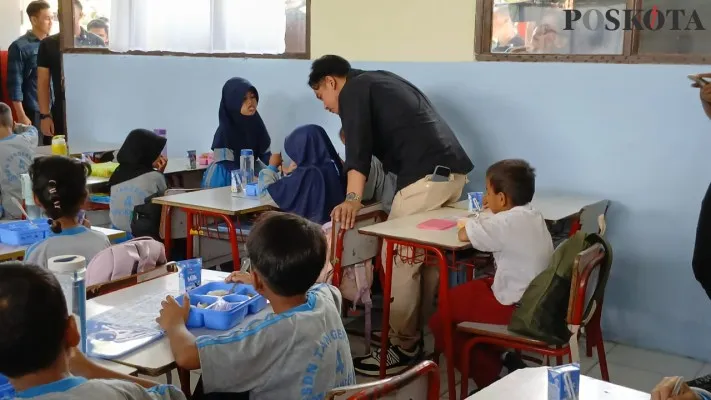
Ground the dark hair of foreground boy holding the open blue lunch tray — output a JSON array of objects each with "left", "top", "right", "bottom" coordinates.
[{"left": 247, "top": 212, "right": 326, "bottom": 297}]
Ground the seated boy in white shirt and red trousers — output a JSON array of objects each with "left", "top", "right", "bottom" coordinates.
[{"left": 429, "top": 160, "right": 553, "bottom": 389}]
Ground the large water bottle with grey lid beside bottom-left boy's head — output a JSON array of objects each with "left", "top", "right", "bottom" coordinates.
[{"left": 47, "top": 256, "right": 86, "bottom": 353}]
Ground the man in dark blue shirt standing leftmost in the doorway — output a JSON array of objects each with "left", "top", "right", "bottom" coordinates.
[{"left": 7, "top": 0, "right": 53, "bottom": 129}]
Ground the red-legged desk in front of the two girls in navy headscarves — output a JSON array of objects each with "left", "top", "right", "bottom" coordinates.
[{"left": 153, "top": 187, "right": 274, "bottom": 271}]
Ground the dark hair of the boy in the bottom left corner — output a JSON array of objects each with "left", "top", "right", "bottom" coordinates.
[{"left": 0, "top": 262, "right": 69, "bottom": 378}]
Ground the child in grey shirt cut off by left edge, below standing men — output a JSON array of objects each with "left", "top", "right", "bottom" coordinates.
[{"left": 0, "top": 103, "right": 37, "bottom": 219}]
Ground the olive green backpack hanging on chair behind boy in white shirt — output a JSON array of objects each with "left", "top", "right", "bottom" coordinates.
[{"left": 508, "top": 231, "right": 612, "bottom": 345}]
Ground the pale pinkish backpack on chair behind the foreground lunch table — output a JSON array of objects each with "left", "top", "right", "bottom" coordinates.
[{"left": 85, "top": 237, "right": 168, "bottom": 286}]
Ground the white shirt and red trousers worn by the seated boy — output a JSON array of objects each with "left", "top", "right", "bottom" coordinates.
[{"left": 429, "top": 205, "right": 553, "bottom": 389}]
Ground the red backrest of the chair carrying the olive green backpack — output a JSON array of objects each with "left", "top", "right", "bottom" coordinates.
[{"left": 566, "top": 243, "right": 610, "bottom": 326}]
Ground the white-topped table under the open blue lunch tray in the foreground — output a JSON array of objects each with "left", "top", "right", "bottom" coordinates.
[{"left": 86, "top": 269, "right": 271, "bottom": 393}]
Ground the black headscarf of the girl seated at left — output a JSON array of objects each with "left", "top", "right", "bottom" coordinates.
[{"left": 109, "top": 129, "right": 166, "bottom": 186}]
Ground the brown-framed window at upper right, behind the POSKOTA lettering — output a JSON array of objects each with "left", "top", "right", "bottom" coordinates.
[{"left": 475, "top": 0, "right": 711, "bottom": 63}]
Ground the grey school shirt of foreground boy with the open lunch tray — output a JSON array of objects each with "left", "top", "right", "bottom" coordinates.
[{"left": 197, "top": 284, "right": 356, "bottom": 400}]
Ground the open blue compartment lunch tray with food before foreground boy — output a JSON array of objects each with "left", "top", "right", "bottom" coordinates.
[{"left": 176, "top": 282, "right": 267, "bottom": 331}]
